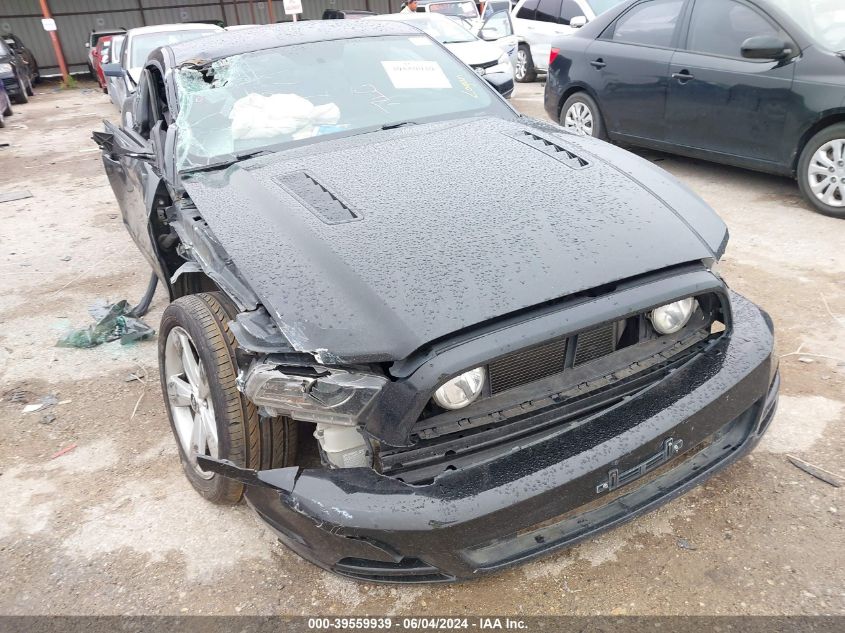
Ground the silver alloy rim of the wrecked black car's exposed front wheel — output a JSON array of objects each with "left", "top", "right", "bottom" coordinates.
[{"left": 164, "top": 326, "right": 220, "bottom": 479}]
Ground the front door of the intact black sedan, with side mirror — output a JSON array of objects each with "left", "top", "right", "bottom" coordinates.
[{"left": 667, "top": 0, "right": 800, "bottom": 163}]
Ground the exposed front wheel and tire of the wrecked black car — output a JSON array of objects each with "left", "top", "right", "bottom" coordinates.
[{"left": 158, "top": 292, "right": 296, "bottom": 504}]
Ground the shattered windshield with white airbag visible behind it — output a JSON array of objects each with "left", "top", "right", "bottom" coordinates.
[{"left": 176, "top": 35, "right": 511, "bottom": 171}]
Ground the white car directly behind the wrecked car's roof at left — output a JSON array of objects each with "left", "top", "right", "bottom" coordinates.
[{"left": 103, "top": 24, "right": 223, "bottom": 109}]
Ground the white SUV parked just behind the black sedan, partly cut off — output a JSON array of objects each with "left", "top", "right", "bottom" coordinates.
[{"left": 511, "top": 0, "right": 622, "bottom": 82}]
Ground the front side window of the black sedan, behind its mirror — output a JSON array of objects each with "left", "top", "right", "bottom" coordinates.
[{"left": 687, "top": 0, "right": 785, "bottom": 57}]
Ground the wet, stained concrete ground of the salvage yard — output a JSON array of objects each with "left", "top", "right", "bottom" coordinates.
[{"left": 0, "top": 76, "right": 845, "bottom": 615}]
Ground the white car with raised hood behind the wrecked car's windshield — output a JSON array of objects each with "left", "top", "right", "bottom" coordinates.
[{"left": 364, "top": 13, "right": 516, "bottom": 99}]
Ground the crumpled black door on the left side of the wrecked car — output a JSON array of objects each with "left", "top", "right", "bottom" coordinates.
[{"left": 94, "top": 70, "right": 166, "bottom": 279}]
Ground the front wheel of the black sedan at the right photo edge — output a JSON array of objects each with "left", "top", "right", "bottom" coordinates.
[{"left": 798, "top": 123, "right": 845, "bottom": 219}]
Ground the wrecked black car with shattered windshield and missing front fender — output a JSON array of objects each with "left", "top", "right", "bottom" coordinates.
[{"left": 95, "top": 20, "right": 779, "bottom": 582}]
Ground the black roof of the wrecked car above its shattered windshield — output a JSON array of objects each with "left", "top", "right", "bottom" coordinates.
[{"left": 167, "top": 20, "right": 420, "bottom": 66}]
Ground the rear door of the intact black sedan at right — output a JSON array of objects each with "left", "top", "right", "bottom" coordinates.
[{"left": 586, "top": 0, "right": 687, "bottom": 141}]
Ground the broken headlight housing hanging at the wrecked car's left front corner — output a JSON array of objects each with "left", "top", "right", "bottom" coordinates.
[{"left": 243, "top": 364, "right": 387, "bottom": 426}]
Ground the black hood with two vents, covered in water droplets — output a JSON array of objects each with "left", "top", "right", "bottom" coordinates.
[{"left": 184, "top": 118, "right": 725, "bottom": 362}]
